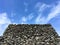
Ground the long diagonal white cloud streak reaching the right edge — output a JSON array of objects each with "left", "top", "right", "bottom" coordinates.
[{"left": 47, "top": 2, "right": 60, "bottom": 21}]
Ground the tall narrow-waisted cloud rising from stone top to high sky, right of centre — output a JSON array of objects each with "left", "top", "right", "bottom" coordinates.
[{"left": 35, "top": 2, "right": 50, "bottom": 24}]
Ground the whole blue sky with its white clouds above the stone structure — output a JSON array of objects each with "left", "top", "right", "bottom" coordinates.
[{"left": 0, "top": 0, "right": 60, "bottom": 35}]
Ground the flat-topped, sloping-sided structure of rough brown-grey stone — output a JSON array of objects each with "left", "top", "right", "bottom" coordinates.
[{"left": 0, "top": 24, "right": 60, "bottom": 45}]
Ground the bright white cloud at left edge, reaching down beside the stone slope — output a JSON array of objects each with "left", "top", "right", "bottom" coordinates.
[{"left": 0, "top": 13, "right": 11, "bottom": 35}]
